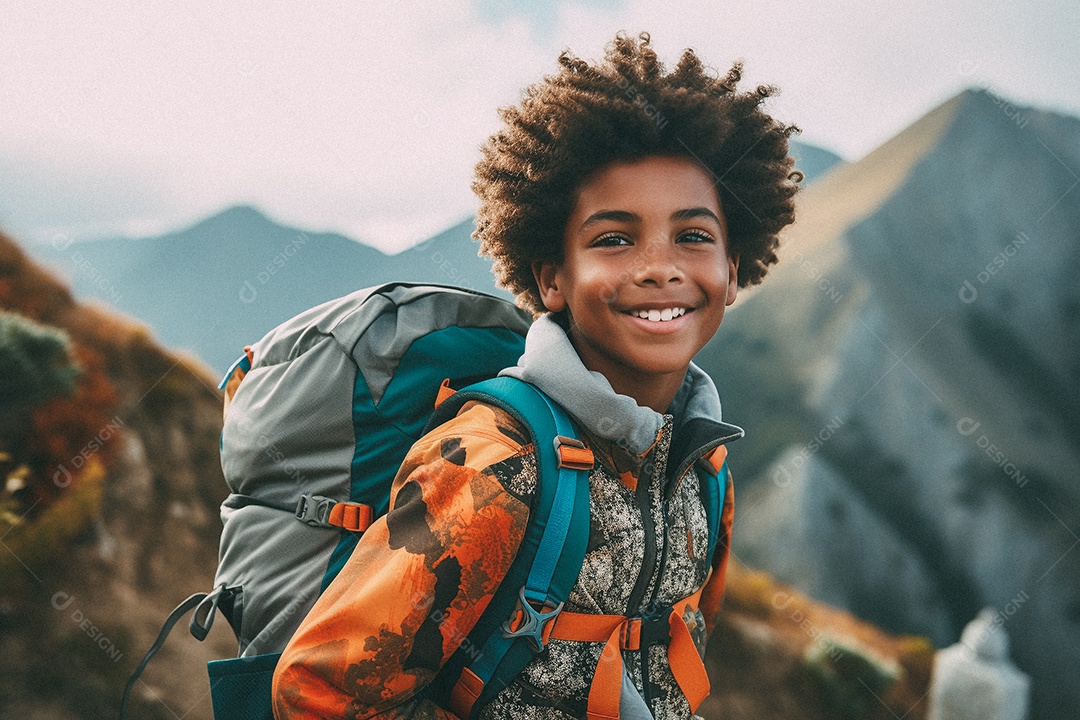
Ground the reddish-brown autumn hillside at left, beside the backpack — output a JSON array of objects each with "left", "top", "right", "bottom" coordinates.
[{"left": 0, "top": 235, "right": 234, "bottom": 720}]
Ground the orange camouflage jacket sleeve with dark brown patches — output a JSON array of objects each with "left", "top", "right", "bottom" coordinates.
[{"left": 273, "top": 403, "right": 535, "bottom": 720}]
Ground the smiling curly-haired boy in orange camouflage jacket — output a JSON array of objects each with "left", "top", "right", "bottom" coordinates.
[{"left": 274, "top": 35, "right": 798, "bottom": 720}]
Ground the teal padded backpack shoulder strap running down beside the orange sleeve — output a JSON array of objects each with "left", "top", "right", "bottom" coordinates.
[{"left": 429, "top": 377, "right": 593, "bottom": 720}]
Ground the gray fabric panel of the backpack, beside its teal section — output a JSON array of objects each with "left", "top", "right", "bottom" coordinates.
[{"left": 214, "top": 284, "right": 528, "bottom": 656}]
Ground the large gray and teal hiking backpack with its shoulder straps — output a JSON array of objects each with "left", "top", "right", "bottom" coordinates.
[{"left": 121, "top": 283, "right": 726, "bottom": 720}]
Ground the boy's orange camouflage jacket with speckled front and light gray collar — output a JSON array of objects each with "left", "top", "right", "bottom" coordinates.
[{"left": 274, "top": 315, "right": 742, "bottom": 720}]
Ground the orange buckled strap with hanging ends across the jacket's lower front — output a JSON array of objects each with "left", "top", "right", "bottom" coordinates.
[{"left": 551, "top": 590, "right": 708, "bottom": 720}]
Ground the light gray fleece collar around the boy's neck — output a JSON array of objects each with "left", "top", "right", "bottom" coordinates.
[{"left": 499, "top": 314, "right": 720, "bottom": 454}]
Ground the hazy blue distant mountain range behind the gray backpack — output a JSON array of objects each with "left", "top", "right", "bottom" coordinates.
[{"left": 21, "top": 144, "right": 841, "bottom": 372}]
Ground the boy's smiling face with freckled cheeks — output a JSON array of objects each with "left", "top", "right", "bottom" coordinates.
[{"left": 534, "top": 157, "right": 739, "bottom": 411}]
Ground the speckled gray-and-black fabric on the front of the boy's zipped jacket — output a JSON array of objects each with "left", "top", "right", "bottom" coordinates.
[{"left": 481, "top": 416, "right": 708, "bottom": 720}]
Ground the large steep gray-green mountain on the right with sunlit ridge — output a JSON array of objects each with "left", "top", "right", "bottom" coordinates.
[{"left": 699, "top": 91, "right": 1080, "bottom": 718}]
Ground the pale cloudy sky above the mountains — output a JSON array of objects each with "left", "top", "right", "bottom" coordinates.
[{"left": 0, "top": 0, "right": 1080, "bottom": 252}]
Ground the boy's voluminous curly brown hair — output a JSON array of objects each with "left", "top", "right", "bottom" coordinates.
[{"left": 472, "top": 32, "right": 802, "bottom": 312}]
